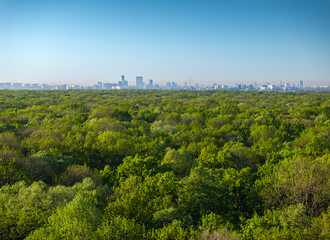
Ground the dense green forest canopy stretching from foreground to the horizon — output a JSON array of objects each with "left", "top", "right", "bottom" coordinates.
[{"left": 0, "top": 90, "right": 330, "bottom": 240}]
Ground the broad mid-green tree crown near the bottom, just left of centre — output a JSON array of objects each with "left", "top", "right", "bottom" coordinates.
[{"left": 106, "top": 172, "right": 177, "bottom": 223}]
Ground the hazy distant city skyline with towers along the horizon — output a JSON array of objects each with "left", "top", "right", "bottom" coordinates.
[{"left": 0, "top": 75, "right": 330, "bottom": 92}]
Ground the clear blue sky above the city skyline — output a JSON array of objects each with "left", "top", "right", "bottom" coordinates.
[{"left": 0, "top": 0, "right": 330, "bottom": 84}]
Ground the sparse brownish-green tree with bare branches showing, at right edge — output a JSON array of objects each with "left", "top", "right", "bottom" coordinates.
[{"left": 261, "top": 155, "right": 330, "bottom": 214}]
